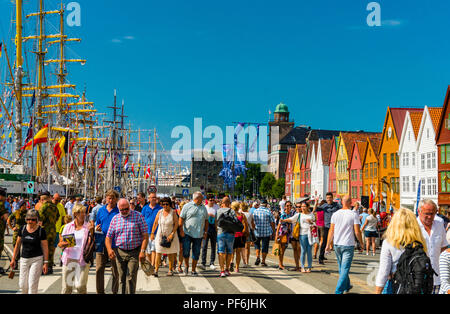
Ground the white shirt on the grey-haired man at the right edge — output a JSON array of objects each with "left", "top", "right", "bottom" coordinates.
[{"left": 417, "top": 216, "right": 448, "bottom": 286}]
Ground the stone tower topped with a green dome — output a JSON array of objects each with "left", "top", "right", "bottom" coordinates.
[{"left": 268, "top": 103, "right": 294, "bottom": 179}]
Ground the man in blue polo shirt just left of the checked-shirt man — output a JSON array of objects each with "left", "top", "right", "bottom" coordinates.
[{"left": 95, "top": 190, "right": 119, "bottom": 294}]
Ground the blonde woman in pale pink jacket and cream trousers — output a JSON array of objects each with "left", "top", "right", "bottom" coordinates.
[{"left": 58, "top": 204, "right": 94, "bottom": 294}]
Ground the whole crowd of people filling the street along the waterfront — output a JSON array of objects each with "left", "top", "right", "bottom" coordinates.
[{"left": 0, "top": 190, "right": 450, "bottom": 294}]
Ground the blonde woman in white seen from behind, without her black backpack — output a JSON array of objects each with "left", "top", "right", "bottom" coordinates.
[{"left": 375, "top": 208, "right": 427, "bottom": 294}]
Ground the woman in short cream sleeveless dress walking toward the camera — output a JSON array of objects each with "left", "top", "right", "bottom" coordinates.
[{"left": 151, "top": 197, "right": 180, "bottom": 277}]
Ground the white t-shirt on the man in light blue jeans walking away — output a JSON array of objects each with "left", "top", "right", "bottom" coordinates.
[{"left": 331, "top": 209, "right": 360, "bottom": 246}]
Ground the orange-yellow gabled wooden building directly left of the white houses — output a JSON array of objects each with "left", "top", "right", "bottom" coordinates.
[{"left": 378, "top": 107, "right": 423, "bottom": 209}]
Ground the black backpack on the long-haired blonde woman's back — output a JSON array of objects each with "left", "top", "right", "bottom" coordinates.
[{"left": 392, "top": 242, "right": 437, "bottom": 294}]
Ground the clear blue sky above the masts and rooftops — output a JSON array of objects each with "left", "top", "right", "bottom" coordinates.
[{"left": 0, "top": 0, "right": 450, "bottom": 156}]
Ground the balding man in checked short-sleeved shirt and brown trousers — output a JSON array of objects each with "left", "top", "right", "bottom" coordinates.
[{"left": 105, "top": 199, "right": 148, "bottom": 294}]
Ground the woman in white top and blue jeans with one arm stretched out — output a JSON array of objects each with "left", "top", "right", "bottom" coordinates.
[{"left": 281, "top": 202, "right": 316, "bottom": 273}]
